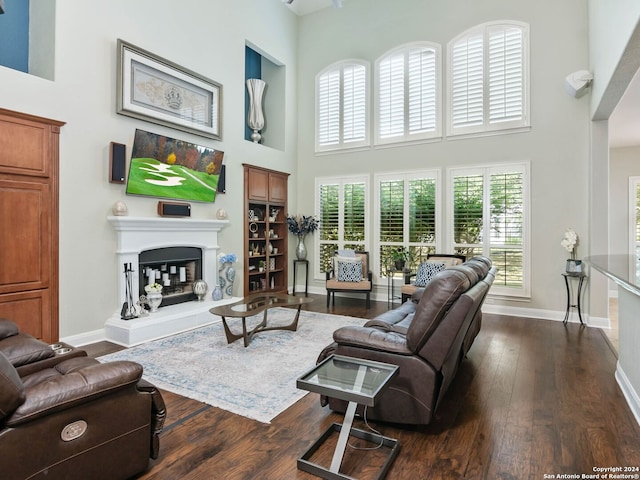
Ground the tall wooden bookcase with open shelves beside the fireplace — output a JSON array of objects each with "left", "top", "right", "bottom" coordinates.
[{"left": 244, "top": 164, "right": 289, "bottom": 296}]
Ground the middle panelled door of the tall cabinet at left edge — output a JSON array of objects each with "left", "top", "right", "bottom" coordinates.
[{"left": 0, "top": 179, "right": 51, "bottom": 294}]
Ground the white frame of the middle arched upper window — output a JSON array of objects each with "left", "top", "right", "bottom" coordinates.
[{"left": 373, "top": 41, "right": 443, "bottom": 147}]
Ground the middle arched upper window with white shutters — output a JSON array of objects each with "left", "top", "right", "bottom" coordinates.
[{"left": 375, "top": 42, "right": 441, "bottom": 144}]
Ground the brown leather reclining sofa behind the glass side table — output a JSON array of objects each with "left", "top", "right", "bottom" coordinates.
[{"left": 318, "top": 257, "right": 497, "bottom": 425}]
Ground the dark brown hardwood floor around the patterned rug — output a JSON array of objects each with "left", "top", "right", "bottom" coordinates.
[{"left": 85, "top": 295, "right": 640, "bottom": 480}]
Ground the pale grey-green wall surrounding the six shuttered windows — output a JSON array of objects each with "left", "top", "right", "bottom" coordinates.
[{"left": 297, "top": 0, "right": 589, "bottom": 311}]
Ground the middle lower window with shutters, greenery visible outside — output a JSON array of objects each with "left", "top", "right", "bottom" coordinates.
[{"left": 374, "top": 171, "right": 440, "bottom": 275}]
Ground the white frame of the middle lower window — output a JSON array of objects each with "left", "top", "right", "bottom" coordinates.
[{"left": 371, "top": 168, "right": 443, "bottom": 278}]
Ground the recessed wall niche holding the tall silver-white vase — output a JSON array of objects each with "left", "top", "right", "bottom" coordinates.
[{"left": 243, "top": 42, "right": 286, "bottom": 150}]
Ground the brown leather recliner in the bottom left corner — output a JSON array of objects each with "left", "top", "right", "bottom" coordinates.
[{"left": 0, "top": 319, "right": 166, "bottom": 480}]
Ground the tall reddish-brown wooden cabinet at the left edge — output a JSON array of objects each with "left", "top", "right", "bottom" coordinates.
[{"left": 0, "top": 109, "right": 64, "bottom": 342}]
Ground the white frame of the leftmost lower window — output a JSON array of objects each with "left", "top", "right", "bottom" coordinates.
[{"left": 313, "top": 174, "right": 371, "bottom": 280}]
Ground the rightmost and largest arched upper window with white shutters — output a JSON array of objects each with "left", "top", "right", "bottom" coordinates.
[{"left": 447, "top": 22, "right": 530, "bottom": 135}]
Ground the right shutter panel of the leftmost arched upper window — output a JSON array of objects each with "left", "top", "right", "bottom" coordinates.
[{"left": 342, "top": 65, "right": 367, "bottom": 143}]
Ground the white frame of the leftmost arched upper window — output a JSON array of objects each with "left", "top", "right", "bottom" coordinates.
[{"left": 315, "top": 59, "right": 371, "bottom": 153}]
